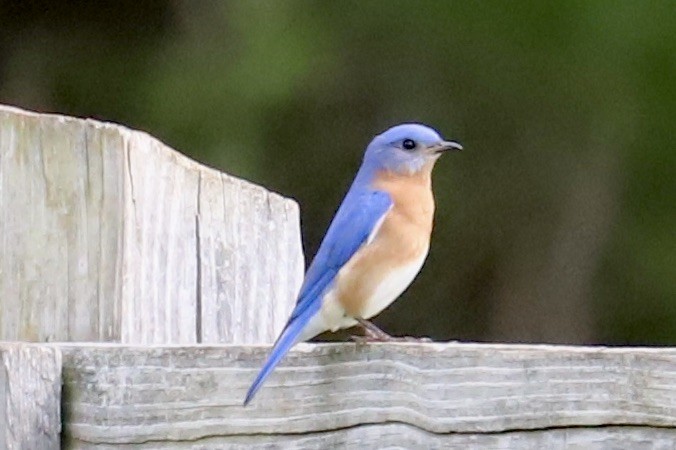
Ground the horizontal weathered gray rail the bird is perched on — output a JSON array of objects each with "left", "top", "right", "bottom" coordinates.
[{"left": 60, "top": 343, "right": 676, "bottom": 448}]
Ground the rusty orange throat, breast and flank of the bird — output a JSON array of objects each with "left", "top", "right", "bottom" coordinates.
[{"left": 336, "top": 163, "right": 434, "bottom": 318}]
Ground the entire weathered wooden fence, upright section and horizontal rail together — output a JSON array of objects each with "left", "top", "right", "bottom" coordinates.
[{"left": 0, "top": 107, "right": 676, "bottom": 450}]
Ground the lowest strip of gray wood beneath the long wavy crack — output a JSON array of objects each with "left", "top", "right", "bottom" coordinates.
[{"left": 58, "top": 423, "right": 676, "bottom": 450}]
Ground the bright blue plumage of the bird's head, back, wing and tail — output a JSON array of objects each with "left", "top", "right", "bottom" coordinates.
[{"left": 244, "top": 124, "right": 462, "bottom": 405}]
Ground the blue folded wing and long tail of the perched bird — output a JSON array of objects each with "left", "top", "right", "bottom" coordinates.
[{"left": 244, "top": 190, "right": 392, "bottom": 405}]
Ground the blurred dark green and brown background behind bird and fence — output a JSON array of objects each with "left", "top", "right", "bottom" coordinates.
[{"left": 0, "top": 0, "right": 676, "bottom": 344}]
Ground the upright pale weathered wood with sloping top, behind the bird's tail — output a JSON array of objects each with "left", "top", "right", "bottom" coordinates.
[{"left": 0, "top": 105, "right": 303, "bottom": 344}]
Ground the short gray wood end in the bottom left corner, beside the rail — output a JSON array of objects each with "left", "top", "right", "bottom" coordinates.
[{"left": 0, "top": 342, "right": 61, "bottom": 450}]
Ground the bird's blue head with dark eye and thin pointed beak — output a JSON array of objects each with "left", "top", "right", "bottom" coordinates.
[{"left": 364, "top": 123, "right": 462, "bottom": 175}]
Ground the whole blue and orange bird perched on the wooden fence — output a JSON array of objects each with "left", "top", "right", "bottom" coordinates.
[{"left": 244, "top": 123, "right": 463, "bottom": 406}]
